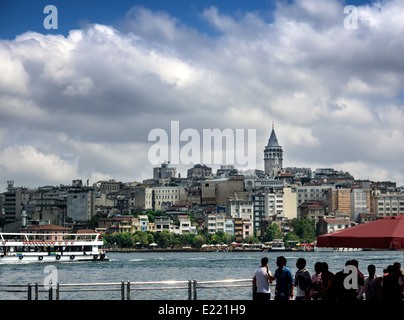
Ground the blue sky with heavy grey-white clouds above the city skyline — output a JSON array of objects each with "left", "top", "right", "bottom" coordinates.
[{"left": 0, "top": 0, "right": 404, "bottom": 190}]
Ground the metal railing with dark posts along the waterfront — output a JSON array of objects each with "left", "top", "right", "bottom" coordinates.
[{"left": 0, "top": 279, "right": 253, "bottom": 300}]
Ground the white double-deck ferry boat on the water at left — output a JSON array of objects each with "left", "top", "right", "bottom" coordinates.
[{"left": 0, "top": 233, "right": 108, "bottom": 263}]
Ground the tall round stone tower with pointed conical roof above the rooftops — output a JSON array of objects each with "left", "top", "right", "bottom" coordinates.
[{"left": 264, "top": 122, "right": 283, "bottom": 178}]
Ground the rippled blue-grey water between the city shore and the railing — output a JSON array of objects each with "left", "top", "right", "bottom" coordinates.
[{"left": 0, "top": 251, "right": 403, "bottom": 300}]
